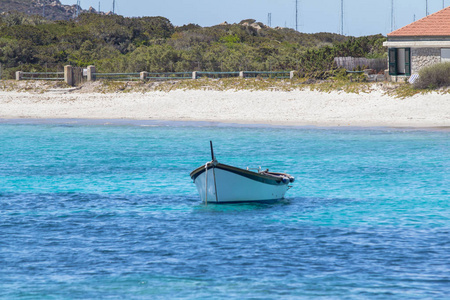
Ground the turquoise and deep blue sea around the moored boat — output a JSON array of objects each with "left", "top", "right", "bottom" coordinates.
[{"left": 0, "top": 120, "right": 450, "bottom": 299}]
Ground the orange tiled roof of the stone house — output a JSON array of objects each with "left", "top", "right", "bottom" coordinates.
[{"left": 388, "top": 6, "right": 450, "bottom": 37}]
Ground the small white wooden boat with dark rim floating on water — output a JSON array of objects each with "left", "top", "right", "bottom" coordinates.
[{"left": 190, "top": 142, "right": 294, "bottom": 203}]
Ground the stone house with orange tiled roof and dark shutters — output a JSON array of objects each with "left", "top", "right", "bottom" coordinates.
[{"left": 383, "top": 7, "right": 450, "bottom": 80}]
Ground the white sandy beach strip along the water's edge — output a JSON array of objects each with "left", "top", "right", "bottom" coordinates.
[{"left": 0, "top": 90, "right": 450, "bottom": 127}]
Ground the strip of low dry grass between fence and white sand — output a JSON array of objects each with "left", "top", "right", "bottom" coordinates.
[{"left": 0, "top": 78, "right": 450, "bottom": 99}]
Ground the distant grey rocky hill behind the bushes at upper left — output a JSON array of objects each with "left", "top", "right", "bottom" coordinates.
[{"left": 0, "top": 0, "right": 96, "bottom": 20}]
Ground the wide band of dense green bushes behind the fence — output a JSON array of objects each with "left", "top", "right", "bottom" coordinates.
[{"left": 0, "top": 13, "right": 386, "bottom": 79}]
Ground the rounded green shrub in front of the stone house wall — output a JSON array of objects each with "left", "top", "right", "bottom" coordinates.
[{"left": 414, "top": 62, "right": 450, "bottom": 89}]
